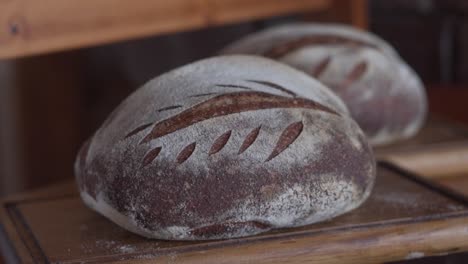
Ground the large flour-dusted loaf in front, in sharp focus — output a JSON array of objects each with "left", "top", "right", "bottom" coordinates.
[{"left": 75, "top": 56, "right": 375, "bottom": 240}]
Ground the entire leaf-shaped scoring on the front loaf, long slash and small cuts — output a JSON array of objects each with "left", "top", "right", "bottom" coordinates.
[{"left": 125, "top": 80, "right": 340, "bottom": 167}]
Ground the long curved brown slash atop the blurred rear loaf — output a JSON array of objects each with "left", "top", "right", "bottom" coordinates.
[{"left": 263, "top": 35, "right": 380, "bottom": 59}]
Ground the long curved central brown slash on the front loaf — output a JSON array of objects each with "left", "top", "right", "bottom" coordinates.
[{"left": 140, "top": 92, "right": 340, "bottom": 144}]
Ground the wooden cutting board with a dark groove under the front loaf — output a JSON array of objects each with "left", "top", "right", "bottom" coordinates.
[{"left": 0, "top": 163, "right": 468, "bottom": 263}]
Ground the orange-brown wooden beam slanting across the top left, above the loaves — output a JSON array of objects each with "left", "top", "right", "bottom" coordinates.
[{"left": 0, "top": 0, "right": 332, "bottom": 59}]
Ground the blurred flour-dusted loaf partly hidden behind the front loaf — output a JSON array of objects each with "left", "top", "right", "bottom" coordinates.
[{"left": 221, "top": 23, "right": 427, "bottom": 145}]
